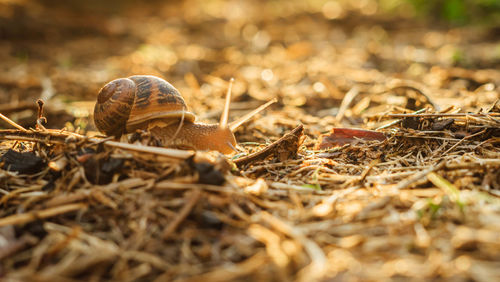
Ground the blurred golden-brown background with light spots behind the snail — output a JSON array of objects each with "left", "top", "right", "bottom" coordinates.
[{"left": 0, "top": 0, "right": 500, "bottom": 131}]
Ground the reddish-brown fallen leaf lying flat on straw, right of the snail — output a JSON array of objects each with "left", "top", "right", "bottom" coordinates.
[{"left": 315, "top": 128, "right": 387, "bottom": 150}]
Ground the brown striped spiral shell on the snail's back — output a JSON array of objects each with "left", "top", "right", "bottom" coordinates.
[{"left": 94, "top": 75, "right": 195, "bottom": 136}]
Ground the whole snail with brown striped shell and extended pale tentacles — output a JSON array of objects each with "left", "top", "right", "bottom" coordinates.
[{"left": 94, "top": 75, "right": 275, "bottom": 154}]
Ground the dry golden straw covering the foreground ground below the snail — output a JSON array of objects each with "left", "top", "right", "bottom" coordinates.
[{"left": 0, "top": 103, "right": 500, "bottom": 281}]
